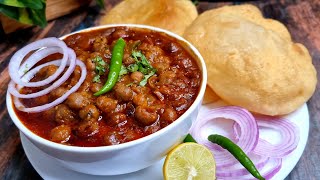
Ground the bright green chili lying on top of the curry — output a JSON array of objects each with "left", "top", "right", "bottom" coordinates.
[{"left": 94, "top": 38, "right": 126, "bottom": 96}]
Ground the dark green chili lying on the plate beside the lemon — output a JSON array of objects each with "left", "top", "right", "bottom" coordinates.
[{"left": 208, "top": 134, "right": 264, "bottom": 180}]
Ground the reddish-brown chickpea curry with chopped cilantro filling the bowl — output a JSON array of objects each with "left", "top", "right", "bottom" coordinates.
[{"left": 15, "top": 27, "right": 201, "bottom": 147}]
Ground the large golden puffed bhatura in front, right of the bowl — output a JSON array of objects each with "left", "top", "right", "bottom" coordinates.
[{"left": 184, "top": 5, "right": 317, "bottom": 115}]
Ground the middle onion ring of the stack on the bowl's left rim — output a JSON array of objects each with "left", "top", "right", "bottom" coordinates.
[{"left": 8, "top": 49, "right": 76, "bottom": 98}]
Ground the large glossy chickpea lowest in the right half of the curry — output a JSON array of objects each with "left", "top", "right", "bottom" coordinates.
[{"left": 134, "top": 106, "right": 159, "bottom": 126}]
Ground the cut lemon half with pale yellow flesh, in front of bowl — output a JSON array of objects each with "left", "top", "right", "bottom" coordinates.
[{"left": 163, "top": 143, "right": 216, "bottom": 180}]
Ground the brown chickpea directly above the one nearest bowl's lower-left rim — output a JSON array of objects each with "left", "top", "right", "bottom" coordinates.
[{"left": 55, "top": 104, "right": 77, "bottom": 124}]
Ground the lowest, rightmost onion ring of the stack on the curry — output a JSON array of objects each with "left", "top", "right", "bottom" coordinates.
[{"left": 13, "top": 60, "right": 87, "bottom": 112}]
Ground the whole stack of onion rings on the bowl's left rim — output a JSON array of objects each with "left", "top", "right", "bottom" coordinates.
[{"left": 8, "top": 37, "right": 87, "bottom": 112}]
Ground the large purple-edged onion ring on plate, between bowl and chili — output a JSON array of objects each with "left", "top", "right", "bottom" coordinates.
[{"left": 190, "top": 106, "right": 259, "bottom": 167}]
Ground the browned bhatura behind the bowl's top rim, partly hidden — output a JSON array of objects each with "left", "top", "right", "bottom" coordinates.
[{"left": 100, "top": 0, "right": 198, "bottom": 35}]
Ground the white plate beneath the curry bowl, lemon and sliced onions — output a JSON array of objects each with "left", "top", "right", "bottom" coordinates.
[{"left": 20, "top": 104, "right": 309, "bottom": 180}]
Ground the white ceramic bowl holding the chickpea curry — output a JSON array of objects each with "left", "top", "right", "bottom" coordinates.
[{"left": 6, "top": 24, "right": 207, "bottom": 175}]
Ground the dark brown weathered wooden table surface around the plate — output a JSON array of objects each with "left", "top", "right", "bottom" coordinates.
[{"left": 0, "top": 0, "right": 320, "bottom": 180}]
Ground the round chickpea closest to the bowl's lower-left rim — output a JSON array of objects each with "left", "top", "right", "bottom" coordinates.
[{"left": 50, "top": 125, "right": 71, "bottom": 143}]
